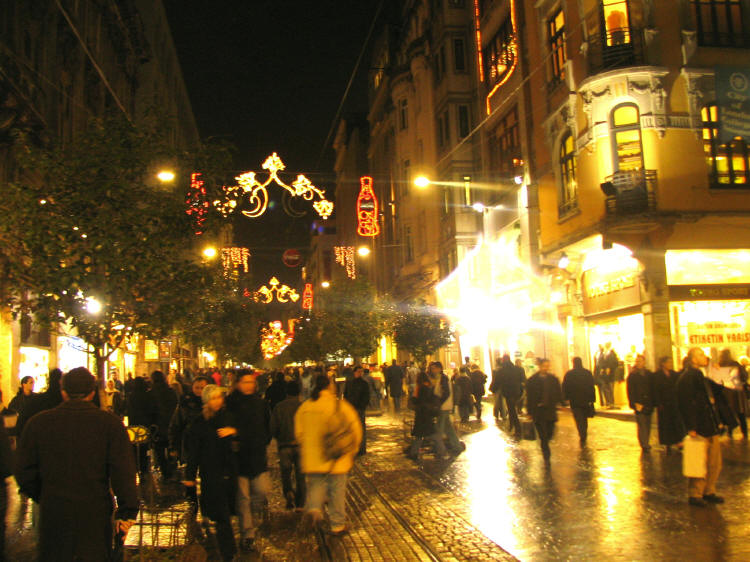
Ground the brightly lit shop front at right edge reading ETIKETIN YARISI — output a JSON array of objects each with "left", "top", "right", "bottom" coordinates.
[{"left": 665, "top": 249, "right": 750, "bottom": 365}]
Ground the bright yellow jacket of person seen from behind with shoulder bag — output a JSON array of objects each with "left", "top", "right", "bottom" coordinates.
[{"left": 294, "top": 389, "right": 362, "bottom": 474}]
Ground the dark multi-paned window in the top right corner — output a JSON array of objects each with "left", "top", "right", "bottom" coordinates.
[{"left": 692, "top": 0, "right": 750, "bottom": 47}]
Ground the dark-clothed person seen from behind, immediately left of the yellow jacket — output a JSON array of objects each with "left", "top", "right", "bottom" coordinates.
[{"left": 271, "top": 380, "right": 306, "bottom": 509}]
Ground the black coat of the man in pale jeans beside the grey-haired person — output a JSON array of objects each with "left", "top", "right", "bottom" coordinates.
[{"left": 226, "top": 390, "right": 271, "bottom": 478}]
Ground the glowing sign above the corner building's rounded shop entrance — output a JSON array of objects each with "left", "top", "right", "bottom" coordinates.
[{"left": 583, "top": 269, "right": 641, "bottom": 315}]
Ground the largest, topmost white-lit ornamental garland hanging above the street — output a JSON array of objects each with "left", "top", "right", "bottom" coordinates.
[{"left": 214, "top": 152, "right": 333, "bottom": 220}]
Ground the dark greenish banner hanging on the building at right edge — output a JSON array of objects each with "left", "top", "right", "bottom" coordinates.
[{"left": 716, "top": 66, "right": 750, "bottom": 143}]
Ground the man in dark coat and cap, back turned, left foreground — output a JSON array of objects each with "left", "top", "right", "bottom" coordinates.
[{"left": 15, "top": 367, "right": 138, "bottom": 562}]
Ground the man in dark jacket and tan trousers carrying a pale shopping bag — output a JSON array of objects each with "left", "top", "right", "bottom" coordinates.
[{"left": 677, "top": 347, "right": 737, "bottom": 507}]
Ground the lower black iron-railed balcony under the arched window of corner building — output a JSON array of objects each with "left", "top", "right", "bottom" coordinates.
[{"left": 601, "top": 170, "right": 656, "bottom": 215}]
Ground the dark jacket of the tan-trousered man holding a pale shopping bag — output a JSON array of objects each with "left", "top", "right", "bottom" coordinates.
[{"left": 677, "top": 367, "right": 737, "bottom": 437}]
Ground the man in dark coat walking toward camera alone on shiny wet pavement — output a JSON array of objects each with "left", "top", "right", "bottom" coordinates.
[{"left": 526, "top": 359, "right": 562, "bottom": 465}]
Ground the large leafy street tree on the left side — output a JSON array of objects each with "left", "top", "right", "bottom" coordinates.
[{"left": 0, "top": 112, "right": 228, "bottom": 377}]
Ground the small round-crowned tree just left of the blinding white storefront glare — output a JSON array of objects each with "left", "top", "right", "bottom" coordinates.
[{"left": 392, "top": 301, "right": 453, "bottom": 364}]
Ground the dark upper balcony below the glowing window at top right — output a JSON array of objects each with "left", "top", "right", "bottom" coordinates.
[{"left": 588, "top": 28, "right": 647, "bottom": 75}]
